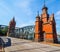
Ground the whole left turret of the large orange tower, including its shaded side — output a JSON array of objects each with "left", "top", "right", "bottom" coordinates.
[{"left": 34, "top": 12, "right": 43, "bottom": 41}]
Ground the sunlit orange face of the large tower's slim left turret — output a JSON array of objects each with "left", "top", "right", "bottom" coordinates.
[{"left": 35, "top": 12, "right": 40, "bottom": 41}]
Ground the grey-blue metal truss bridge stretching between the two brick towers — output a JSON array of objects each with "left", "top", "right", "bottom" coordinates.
[{"left": 0, "top": 25, "right": 60, "bottom": 41}]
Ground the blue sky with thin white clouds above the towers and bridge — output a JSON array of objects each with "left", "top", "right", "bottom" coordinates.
[{"left": 0, "top": 0, "right": 60, "bottom": 34}]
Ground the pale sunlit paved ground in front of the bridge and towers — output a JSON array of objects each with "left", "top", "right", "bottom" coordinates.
[{"left": 5, "top": 38, "right": 60, "bottom": 52}]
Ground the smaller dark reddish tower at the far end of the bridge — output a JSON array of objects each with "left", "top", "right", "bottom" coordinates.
[{"left": 8, "top": 17, "right": 16, "bottom": 36}]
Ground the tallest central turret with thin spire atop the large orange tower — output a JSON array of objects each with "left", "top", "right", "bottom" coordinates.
[{"left": 41, "top": 0, "right": 49, "bottom": 23}]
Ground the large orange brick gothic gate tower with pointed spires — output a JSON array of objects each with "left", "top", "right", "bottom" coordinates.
[{"left": 35, "top": 2, "right": 58, "bottom": 43}]
